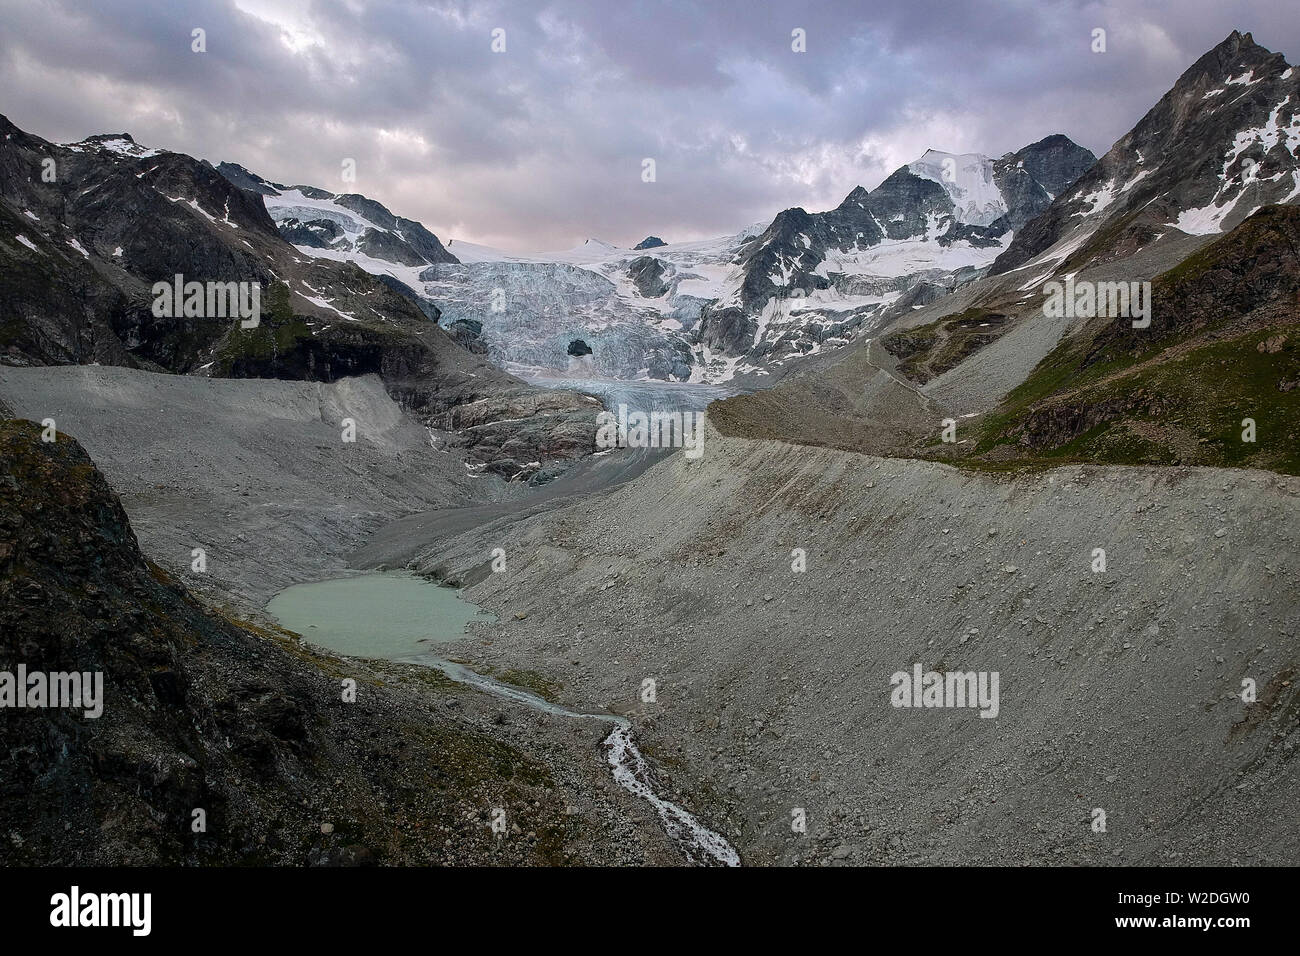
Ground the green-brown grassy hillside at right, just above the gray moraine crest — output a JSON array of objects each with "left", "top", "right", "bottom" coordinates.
[{"left": 963, "top": 206, "right": 1300, "bottom": 475}]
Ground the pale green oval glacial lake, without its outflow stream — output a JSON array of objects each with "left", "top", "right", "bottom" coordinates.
[{"left": 267, "top": 571, "right": 495, "bottom": 661}]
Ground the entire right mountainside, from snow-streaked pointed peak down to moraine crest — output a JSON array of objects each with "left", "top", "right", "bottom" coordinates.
[{"left": 710, "top": 33, "right": 1300, "bottom": 471}]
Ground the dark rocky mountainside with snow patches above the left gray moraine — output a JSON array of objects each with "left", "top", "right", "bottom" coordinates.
[{"left": 0, "top": 117, "right": 594, "bottom": 477}]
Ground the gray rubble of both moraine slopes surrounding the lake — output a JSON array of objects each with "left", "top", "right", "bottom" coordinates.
[{"left": 0, "top": 368, "right": 1300, "bottom": 865}]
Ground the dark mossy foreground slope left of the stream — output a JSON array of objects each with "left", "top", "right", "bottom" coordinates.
[{"left": 0, "top": 420, "right": 673, "bottom": 865}]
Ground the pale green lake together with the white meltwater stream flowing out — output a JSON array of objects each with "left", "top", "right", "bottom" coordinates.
[{"left": 267, "top": 571, "right": 740, "bottom": 866}]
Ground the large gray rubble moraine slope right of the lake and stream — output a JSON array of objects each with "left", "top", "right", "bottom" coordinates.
[{"left": 405, "top": 434, "right": 1300, "bottom": 865}]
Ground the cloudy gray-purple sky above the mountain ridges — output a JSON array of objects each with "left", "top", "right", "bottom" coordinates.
[{"left": 0, "top": 0, "right": 1300, "bottom": 251}]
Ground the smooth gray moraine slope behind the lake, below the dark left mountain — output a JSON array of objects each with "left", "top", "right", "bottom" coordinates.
[{"left": 0, "top": 365, "right": 486, "bottom": 607}]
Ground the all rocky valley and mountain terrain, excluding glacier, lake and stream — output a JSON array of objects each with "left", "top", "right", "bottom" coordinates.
[{"left": 0, "top": 33, "right": 1300, "bottom": 865}]
